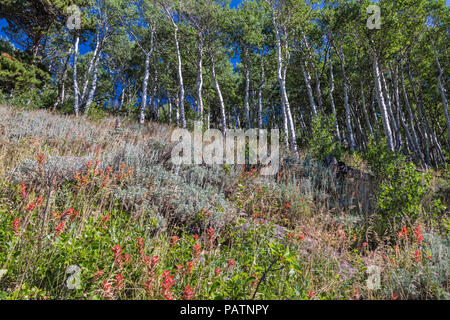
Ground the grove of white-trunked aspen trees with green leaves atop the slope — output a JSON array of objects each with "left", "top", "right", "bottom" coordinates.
[{"left": 0, "top": 0, "right": 450, "bottom": 167}]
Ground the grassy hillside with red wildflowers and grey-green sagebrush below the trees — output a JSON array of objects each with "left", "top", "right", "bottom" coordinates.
[{"left": 0, "top": 107, "right": 450, "bottom": 299}]
